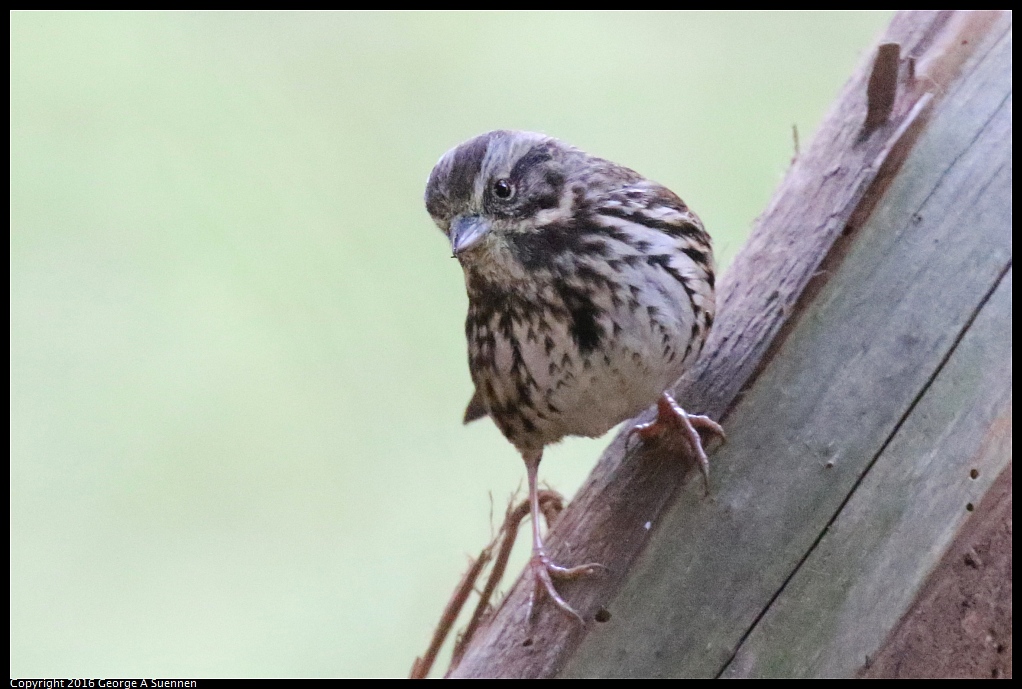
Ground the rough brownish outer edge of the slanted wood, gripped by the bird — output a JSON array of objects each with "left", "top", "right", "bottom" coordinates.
[{"left": 451, "top": 11, "right": 1000, "bottom": 677}]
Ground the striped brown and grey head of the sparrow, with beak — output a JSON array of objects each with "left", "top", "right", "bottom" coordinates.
[{"left": 425, "top": 130, "right": 596, "bottom": 268}]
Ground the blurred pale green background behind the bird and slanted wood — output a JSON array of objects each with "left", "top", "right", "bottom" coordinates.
[{"left": 10, "top": 12, "right": 889, "bottom": 677}]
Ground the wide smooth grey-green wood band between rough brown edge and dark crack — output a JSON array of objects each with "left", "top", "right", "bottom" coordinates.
[{"left": 564, "top": 16, "right": 1012, "bottom": 677}]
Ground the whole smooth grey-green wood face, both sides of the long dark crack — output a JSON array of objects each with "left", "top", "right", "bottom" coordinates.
[{"left": 562, "top": 18, "right": 1012, "bottom": 677}]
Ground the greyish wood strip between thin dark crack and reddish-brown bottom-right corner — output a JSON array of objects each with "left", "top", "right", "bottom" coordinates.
[{"left": 725, "top": 271, "right": 1012, "bottom": 677}]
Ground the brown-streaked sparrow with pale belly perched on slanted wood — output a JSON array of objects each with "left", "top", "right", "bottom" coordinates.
[{"left": 425, "top": 131, "right": 723, "bottom": 616}]
